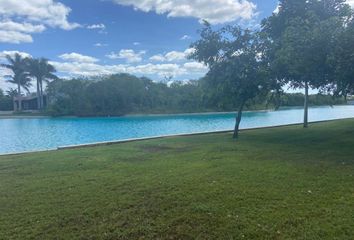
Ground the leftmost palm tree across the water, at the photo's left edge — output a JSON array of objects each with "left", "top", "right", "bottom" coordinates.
[{"left": 1, "top": 53, "right": 31, "bottom": 111}]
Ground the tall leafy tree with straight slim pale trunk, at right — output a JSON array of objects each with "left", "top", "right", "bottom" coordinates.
[{"left": 262, "top": 0, "right": 348, "bottom": 127}]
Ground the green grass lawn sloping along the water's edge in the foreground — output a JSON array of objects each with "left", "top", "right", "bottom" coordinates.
[{"left": 0, "top": 120, "right": 354, "bottom": 240}]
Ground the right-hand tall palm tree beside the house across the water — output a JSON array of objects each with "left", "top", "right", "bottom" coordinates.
[{"left": 28, "top": 58, "right": 58, "bottom": 109}]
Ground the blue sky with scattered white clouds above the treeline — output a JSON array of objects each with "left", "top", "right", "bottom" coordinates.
[{"left": 0, "top": 0, "right": 277, "bottom": 87}]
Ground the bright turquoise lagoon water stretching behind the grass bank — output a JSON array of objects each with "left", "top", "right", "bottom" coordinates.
[{"left": 0, "top": 106, "right": 354, "bottom": 154}]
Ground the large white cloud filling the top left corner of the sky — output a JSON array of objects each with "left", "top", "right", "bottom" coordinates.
[{"left": 0, "top": 0, "right": 80, "bottom": 43}]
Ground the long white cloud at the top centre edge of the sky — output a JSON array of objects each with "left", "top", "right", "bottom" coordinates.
[{"left": 113, "top": 0, "right": 256, "bottom": 24}]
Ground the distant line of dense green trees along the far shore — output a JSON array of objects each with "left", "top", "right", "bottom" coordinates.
[{"left": 24, "top": 74, "right": 345, "bottom": 116}]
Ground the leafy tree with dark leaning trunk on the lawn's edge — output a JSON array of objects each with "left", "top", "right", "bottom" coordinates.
[{"left": 190, "top": 22, "right": 268, "bottom": 138}]
